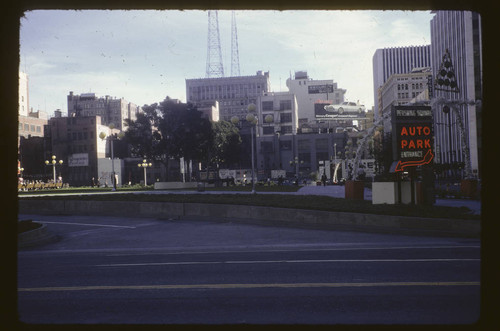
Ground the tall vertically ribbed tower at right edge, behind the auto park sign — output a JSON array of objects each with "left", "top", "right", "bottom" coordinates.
[{"left": 431, "top": 11, "right": 482, "bottom": 174}]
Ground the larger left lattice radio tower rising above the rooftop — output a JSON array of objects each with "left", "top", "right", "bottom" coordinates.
[{"left": 206, "top": 10, "right": 224, "bottom": 78}]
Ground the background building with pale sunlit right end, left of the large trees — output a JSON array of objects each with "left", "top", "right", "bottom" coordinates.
[{"left": 68, "top": 91, "right": 142, "bottom": 131}]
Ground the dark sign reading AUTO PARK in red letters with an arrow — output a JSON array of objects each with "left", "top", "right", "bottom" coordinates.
[{"left": 391, "top": 106, "right": 434, "bottom": 172}]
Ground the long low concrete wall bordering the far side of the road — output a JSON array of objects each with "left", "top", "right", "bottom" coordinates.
[{"left": 19, "top": 200, "right": 481, "bottom": 238}]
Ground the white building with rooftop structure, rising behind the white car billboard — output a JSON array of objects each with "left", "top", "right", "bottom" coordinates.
[{"left": 286, "top": 71, "right": 346, "bottom": 123}]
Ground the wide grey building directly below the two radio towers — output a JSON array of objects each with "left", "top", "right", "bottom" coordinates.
[{"left": 186, "top": 71, "right": 271, "bottom": 121}]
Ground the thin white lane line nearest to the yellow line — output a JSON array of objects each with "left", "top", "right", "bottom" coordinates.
[{"left": 94, "top": 259, "right": 481, "bottom": 267}]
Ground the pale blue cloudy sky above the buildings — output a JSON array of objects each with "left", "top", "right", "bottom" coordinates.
[{"left": 19, "top": 10, "right": 432, "bottom": 116}]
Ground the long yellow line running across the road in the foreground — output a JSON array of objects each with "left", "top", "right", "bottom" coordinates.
[{"left": 17, "top": 282, "right": 480, "bottom": 292}]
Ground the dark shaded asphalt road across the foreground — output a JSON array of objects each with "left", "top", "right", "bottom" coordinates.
[{"left": 18, "top": 215, "right": 481, "bottom": 324}]
